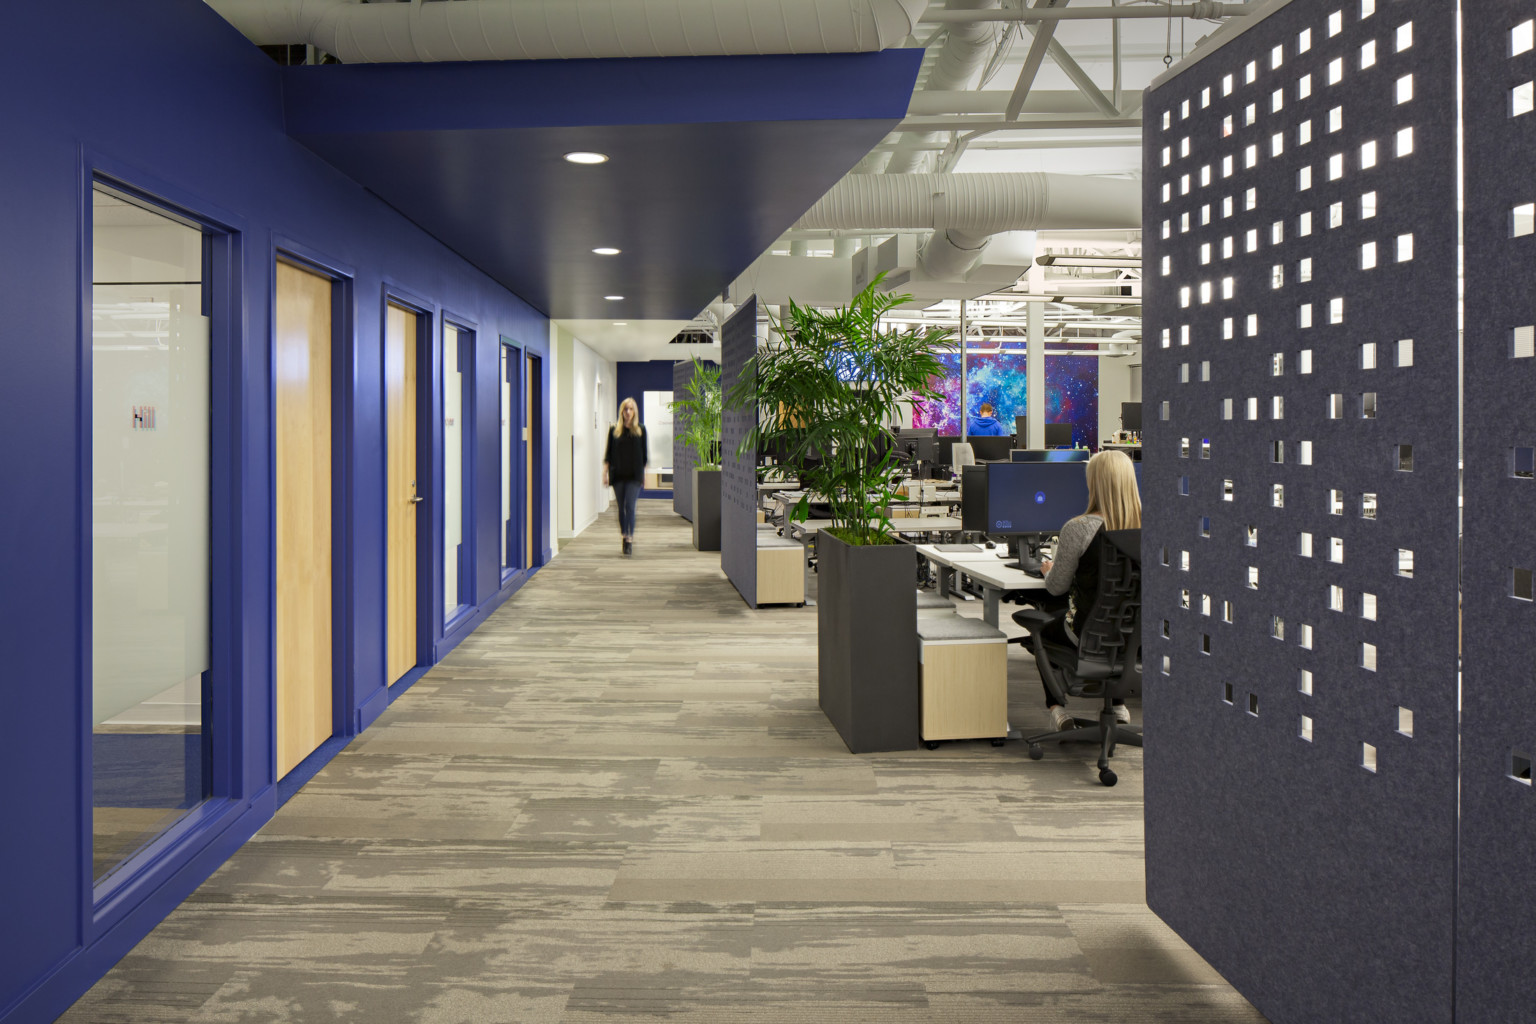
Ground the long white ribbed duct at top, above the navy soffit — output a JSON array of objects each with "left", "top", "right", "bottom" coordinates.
[{"left": 207, "top": 0, "right": 921, "bottom": 63}]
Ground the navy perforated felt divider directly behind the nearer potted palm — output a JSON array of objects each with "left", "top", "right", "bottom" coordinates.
[{"left": 720, "top": 296, "right": 757, "bottom": 608}]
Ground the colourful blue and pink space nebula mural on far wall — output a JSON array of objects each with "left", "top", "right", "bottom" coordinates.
[{"left": 912, "top": 352, "right": 1098, "bottom": 448}]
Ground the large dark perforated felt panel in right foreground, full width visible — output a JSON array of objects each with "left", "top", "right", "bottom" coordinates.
[{"left": 1143, "top": 0, "right": 1458, "bottom": 1022}]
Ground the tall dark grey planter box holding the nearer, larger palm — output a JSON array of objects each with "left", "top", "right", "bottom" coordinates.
[{"left": 816, "top": 530, "right": 920, "bottom": 754}]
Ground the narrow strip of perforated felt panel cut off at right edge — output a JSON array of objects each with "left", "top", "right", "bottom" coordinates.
[{"left": 1456, "top": 0, "right": 1536, "bottom": 1022}]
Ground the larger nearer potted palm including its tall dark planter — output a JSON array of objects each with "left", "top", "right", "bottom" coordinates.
[{"left": 728, "top": 278, "right": 952, "bottom": 754}]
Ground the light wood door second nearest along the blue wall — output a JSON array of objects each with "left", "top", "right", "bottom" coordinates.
[{"left": 384, "top": 306, "right": 425, "bottom": 683}]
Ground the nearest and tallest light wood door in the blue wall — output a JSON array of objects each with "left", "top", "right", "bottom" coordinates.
[{"left": 272, "top": 263, "right": 332, "bottom": 778}]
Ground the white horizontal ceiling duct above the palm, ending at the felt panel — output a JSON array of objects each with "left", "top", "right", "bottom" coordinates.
[{"left": 796, "top": 172, "right": 1141, "bottom": 279}]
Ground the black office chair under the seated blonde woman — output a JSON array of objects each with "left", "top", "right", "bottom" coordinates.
[{"left": 1009, "top": 530, "right": 1141, "bottom": 786}]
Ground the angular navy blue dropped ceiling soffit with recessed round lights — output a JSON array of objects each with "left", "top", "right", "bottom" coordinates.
[{"left": 284, "top": 49, "right": 922, "bottom": 319}]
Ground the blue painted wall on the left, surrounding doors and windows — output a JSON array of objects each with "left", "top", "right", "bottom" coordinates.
[{"left": 0, "top": 0, "right": 552, "bottom": 1024}]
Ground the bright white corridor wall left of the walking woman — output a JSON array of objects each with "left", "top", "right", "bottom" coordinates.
[{"left": 550, "top": 324, "right": 619, "bottom": 537}]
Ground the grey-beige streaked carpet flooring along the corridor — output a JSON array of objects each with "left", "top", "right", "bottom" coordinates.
[{"left": 61, "top": 502, "right": 1264, "bottom": 1024}]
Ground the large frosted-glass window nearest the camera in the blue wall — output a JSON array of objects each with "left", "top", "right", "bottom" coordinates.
[{"left": 91, "top": 192, "right": 210, "bottom": 880}]
